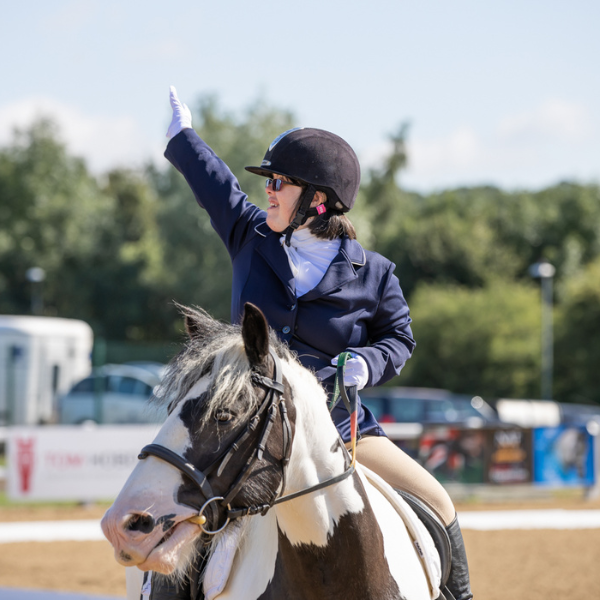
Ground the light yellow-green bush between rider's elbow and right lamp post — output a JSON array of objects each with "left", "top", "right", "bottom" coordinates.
[{"left": 395, "top": 280, "right": 541, "bottom": 398}]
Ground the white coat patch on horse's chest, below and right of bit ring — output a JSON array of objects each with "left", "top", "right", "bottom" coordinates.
[{"left": 212, "top": 511, "right": 279, "bottom": 600}]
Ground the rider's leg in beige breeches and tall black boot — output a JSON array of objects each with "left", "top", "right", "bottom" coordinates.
[{"left": 356, "top": 435, "right": 473, "bottom": 600}]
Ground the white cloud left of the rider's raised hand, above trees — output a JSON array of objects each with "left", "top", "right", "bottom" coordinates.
[{"left": 0, "top": 97, "right": 164, "bottom": 174}]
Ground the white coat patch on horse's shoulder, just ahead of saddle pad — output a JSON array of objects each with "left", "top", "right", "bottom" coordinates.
[{"left": 358, "top": 470, "right": 431, "bottom": 600}]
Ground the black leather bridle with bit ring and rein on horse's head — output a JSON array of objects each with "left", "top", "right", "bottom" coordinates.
[{"left": 138, "top": 349, "right": 354, "bottom": 535}]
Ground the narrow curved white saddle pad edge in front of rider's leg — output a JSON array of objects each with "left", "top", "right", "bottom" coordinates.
[{"left": 356, "top": 464, "right": 442, "bottom": 600}]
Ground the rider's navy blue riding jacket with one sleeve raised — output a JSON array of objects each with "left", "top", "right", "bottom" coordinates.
[{"left": 165, "top": 129, "right": 415, "bottom": 441}]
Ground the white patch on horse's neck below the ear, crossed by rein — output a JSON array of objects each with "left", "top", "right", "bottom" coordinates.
[{"left": 275, "top": 363, "right": 364, "bottom": 546}]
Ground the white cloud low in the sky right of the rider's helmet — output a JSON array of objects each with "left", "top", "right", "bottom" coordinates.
[{"left": 361, "top": 99, "right": 600, "bottom": 190}]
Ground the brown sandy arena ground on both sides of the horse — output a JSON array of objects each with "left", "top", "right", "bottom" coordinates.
[{"left": 0, "top": 498, "right": 600, "bottom": 600}]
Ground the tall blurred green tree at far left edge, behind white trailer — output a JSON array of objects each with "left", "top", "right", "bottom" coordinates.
[{"left": 0, "top": 120, "right": 113, "bottom": 322}]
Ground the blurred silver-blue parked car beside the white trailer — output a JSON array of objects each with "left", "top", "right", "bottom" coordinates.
[{"left": 59, "top": 363, "right": 167, "bottom": 424}]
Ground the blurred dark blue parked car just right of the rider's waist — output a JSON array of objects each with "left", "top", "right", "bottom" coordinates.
[{"left": 360, "top": 387, "right": 498, "bottom": 427}]
